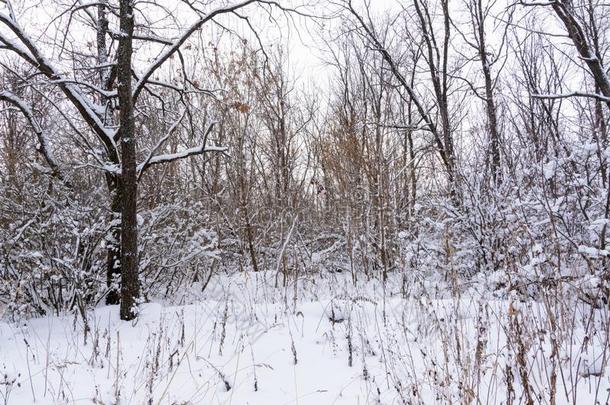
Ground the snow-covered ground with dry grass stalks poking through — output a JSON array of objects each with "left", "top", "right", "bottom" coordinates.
[{"left": 0, "top": 273, "right": 610, "bottom": 405}]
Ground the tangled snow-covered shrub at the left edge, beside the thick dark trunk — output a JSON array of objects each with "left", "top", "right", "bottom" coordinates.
[{"left": 0, "top": 179, "right": 106, "bottom": 315}]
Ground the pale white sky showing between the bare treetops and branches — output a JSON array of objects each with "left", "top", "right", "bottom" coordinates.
[{"left": 0, "top": 0, "right": 580, "bottom": 129}]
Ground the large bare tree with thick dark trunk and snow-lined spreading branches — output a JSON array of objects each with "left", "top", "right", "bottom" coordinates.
[{"left": 0, "top": 0, "right": 294, "bottom": 319}]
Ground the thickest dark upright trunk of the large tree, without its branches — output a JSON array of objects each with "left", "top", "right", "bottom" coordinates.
[{"left": 117, "top": 0, "right": 140, "bottom": 320}]
